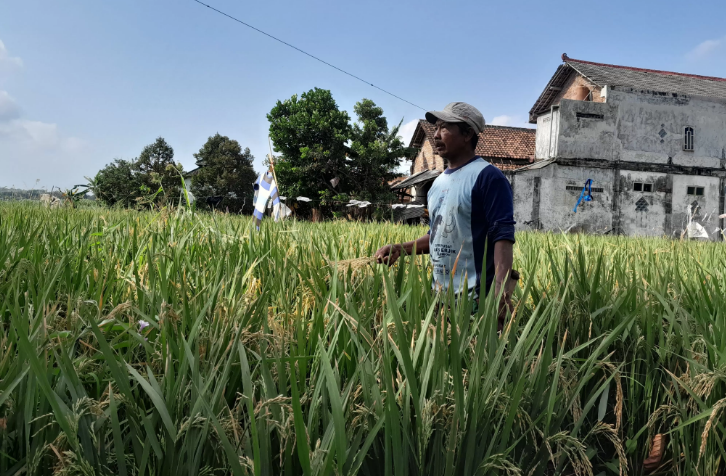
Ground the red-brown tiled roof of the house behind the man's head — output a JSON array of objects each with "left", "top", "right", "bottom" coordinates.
[{"left": 410, "top": 119, "right": 537, "bottom": 163}]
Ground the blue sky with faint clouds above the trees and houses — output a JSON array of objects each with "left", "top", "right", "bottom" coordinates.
[{"left": 0, "top": 0, "right": 726, "bottom": 188}]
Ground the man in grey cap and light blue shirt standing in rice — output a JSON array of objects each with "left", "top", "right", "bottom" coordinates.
[{"left": 375, "top": 102, "right": 516, "bottom": 328}]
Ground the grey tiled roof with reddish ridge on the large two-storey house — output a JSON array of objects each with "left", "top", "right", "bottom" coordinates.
[{"left": 529, "top": 54, "right": 726, "bottom": 123}]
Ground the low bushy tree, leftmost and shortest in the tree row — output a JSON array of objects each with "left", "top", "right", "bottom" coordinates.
[{"left": 90, "top": 159, "right": 141, "bottom": 207}]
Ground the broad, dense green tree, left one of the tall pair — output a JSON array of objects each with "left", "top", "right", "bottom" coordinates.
[{"left": 267, "top": 88, "right": 353, "bottom": 207}]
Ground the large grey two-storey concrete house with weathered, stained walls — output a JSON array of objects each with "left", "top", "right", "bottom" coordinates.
[{"left": 510, "top": 55, "right": 726, "bottom": 240}]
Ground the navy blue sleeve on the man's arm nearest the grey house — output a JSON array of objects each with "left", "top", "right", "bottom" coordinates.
[{"left": 472, "top": 165, "right": 516, "bottom": 245}]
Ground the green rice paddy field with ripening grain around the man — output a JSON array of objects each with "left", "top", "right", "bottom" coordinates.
[{"left": 0, "top": 203, "right": 726, "bottom": 476}]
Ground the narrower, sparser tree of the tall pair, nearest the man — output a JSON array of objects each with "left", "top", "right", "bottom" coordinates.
[{"left": 348, "top": 99, "right": 410, "bottom": 203}]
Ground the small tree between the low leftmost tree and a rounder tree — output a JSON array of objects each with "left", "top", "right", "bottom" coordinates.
[{"left": 135, "top": 137, "right": 183, "bottom": 201}]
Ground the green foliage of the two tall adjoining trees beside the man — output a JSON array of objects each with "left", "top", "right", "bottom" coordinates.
[{"left": 267, "top": 88, "right": 410, "bottom": 217}]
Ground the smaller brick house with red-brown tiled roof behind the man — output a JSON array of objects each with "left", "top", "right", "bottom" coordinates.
[{"left": 391, "top": 119, "right": 535, "bottom": 222}]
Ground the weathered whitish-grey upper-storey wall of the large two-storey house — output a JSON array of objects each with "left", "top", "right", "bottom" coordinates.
[{"left": 536, "top": 88, "right": 726, "bottom": 168}]
